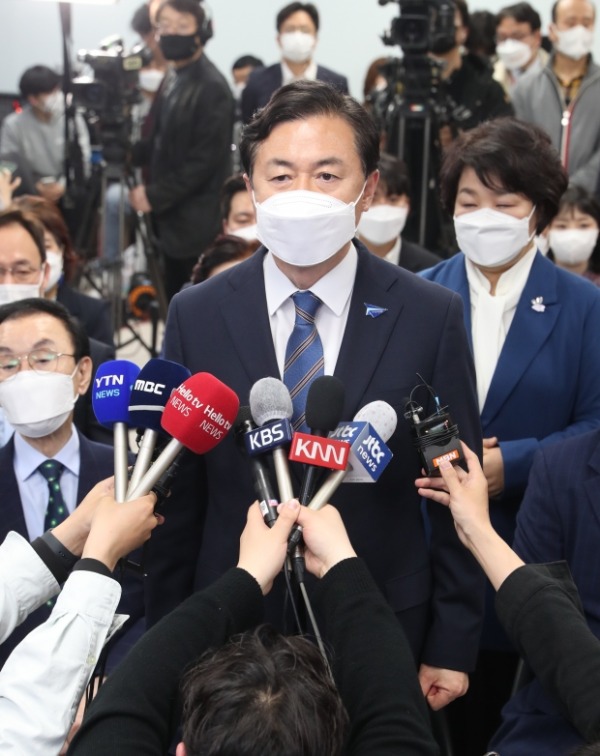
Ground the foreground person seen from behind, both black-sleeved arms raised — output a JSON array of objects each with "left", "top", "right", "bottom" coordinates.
[{"left": 69, "top": 501, "right": 438, "bottom": 756}]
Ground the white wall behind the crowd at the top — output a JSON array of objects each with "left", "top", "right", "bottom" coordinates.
[{"left": 0, "top": 0, "right": 600, "bottom": 99}]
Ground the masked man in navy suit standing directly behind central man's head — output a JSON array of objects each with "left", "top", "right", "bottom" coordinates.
[{"left": 242, "top": 3, "right": 348, "bottom": 123}]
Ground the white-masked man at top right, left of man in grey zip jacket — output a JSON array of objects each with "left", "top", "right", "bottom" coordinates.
[{"left": 494, "top": 2, "right": 548, "bottom": 97}]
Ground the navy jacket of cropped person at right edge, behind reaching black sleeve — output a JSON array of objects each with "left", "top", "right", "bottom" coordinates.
[{"left": 494, "top": 430, "right": 600, "bottom": 756}]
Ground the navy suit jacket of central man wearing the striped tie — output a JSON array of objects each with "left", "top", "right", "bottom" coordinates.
[{"left": 147, "top": 240, "right": 483, "bottom": 670}]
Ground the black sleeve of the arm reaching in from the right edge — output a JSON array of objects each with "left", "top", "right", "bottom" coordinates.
[{"left": 496, "top": 562, "right": 600, "bottom": 742}]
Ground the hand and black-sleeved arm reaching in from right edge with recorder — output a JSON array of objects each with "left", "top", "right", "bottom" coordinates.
[{"left": 416, "top": 444, "right": 600, "bottom": 755}]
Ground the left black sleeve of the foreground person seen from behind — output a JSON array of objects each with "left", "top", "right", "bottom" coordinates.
[{"left": 69, "top": 568, "right": 263, "bottom": 756}]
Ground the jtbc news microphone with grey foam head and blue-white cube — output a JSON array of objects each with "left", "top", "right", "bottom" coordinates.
[{"left": 289, "top": 400, "right": 398, "bottom": 551}]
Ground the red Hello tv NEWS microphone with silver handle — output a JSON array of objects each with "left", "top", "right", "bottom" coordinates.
[{"left": 127, "top": 373, "right": 240, "bottom": 500}]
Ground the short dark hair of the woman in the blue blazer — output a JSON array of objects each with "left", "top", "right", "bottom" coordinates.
[{"left": 440, "top": 118, "right": 568, "bottom": 233}]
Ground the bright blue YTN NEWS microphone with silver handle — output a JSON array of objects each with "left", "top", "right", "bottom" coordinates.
[{"left": 92, "top": 360, "right": 140, "bottom": 502}]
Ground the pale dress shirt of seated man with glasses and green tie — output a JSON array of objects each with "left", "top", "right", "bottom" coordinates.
[{"left": 14, "top": 427, "right": 81, "bottom": 541}]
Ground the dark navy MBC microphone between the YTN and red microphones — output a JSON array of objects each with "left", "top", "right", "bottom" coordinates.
[{"left": 127, "top": 358, "right": 191, "bottom": 495}]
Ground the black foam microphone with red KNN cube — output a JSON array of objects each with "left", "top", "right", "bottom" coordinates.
[{"left": 289, "top": 375, "right": 348, "bottom": 504}]
